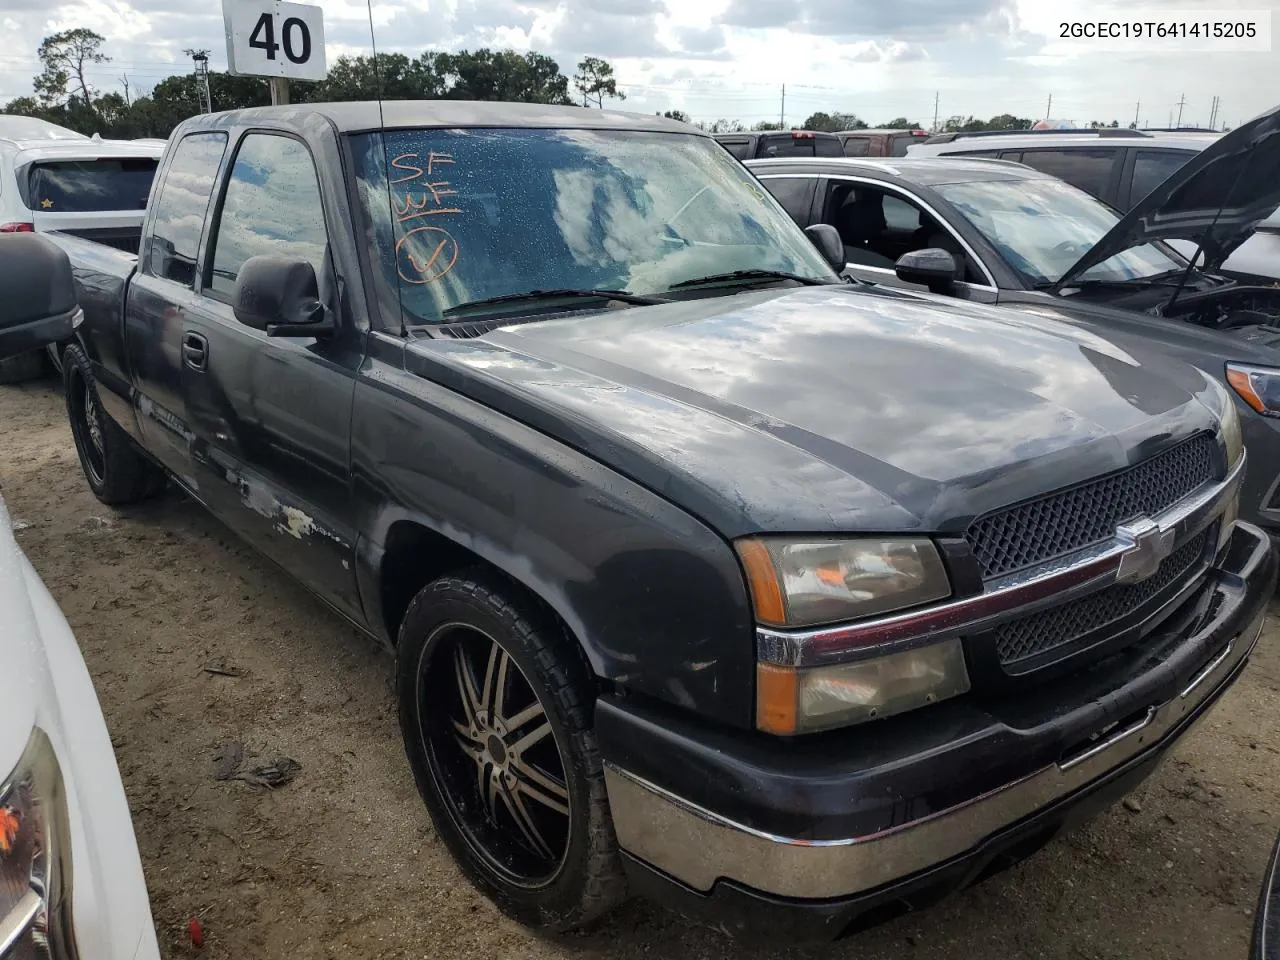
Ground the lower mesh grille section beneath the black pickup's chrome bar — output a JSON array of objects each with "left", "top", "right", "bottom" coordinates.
[{"left": 993, "top": 527, "right": 1213, "bottom": 667}]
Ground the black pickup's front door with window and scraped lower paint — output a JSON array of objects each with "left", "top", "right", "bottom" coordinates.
[{"left": 182, "top": 132, "right": 364, "bottom": 618}]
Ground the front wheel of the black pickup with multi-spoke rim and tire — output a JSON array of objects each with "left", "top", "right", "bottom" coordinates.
[{"left": 396, "top": 568, "right": 626, "bottom": 931}]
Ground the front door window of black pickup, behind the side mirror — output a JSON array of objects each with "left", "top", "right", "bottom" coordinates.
[{"left": 205, "top": 133, "right": 329, "bottom": 300}]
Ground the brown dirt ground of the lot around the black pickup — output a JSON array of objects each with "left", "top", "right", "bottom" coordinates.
[{"left": 0, "top": 384, "right": 1280, "bottom": 960}]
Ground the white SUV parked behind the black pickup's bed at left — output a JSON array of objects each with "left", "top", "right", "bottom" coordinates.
[{"left": 0, "top": 116, "right": 164, "bottom": 383}]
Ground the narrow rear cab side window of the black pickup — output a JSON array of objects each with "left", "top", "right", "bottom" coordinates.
[{"left": 142, "top": 133, "right": 227, "bottom": 287}]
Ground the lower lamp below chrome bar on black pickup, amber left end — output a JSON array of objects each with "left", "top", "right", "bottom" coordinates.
[{"left": 755, "top": 639, "right": 969, "bottom": 735}]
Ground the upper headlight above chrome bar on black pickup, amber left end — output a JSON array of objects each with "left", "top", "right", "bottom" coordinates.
[{"left": 735, "top": 538, "right": 951, "bottom": 627}]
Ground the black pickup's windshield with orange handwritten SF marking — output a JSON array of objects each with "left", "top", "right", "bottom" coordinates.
[{"left": 352, "top": 128, "right": 836, "bottom": 323}]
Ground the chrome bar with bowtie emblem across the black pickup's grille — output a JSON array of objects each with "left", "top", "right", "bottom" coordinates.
[{"left": 755, "top": 456, "right": 1245, "bottom": 667}]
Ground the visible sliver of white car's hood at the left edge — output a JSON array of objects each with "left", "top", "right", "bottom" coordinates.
[{"left": 0, "top": 498, "right": 45, "bottom": 778}]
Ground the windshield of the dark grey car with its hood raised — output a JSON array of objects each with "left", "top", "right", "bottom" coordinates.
[{"left": 934, "top": 180, "right": 1187, "bottom": 285}]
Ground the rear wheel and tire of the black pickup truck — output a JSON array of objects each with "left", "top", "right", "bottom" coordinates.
[{"left": 63, "top": 344, "right": 165, "bottom": 506}]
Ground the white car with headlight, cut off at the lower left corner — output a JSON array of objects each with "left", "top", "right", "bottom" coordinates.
[{"left": 0, "top": 499, "right": 160, "bottom": 960}]
